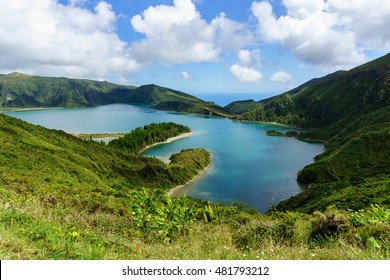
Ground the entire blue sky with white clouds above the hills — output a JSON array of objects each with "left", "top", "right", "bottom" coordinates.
[{"left": 0, "top": 0, "right": 390, "bottom": 100}]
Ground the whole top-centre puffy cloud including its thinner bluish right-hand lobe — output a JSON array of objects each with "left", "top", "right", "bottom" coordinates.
[{"left": 131, "top": 0, "right": 252, "bottom": 64}]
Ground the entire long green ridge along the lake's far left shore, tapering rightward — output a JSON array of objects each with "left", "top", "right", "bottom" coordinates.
[{"left": 0, "top": 73, "right": 229, "bottom": 117}]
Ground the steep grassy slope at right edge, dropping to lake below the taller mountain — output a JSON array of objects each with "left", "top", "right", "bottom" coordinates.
[{"left": 298, "top": 110, "right": 390, "bottom": 186}]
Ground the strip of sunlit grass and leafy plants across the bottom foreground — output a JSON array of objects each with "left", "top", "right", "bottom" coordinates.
[{"left": 0, "top": 185, "right": 390, "bottom": 259}]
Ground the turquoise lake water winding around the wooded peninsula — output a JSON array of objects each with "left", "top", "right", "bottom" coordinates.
[{"left": 6, "top": 104, "right": 323, "bottom": 212}]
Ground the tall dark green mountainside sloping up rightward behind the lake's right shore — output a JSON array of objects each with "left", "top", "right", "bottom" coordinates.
[{"left": 238, "top": 54, "right": 390, "bottom": 128}]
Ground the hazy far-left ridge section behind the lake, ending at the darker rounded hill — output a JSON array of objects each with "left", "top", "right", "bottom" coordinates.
[{"left": 0, "top": 73, "right": 133, "bottom": 108}]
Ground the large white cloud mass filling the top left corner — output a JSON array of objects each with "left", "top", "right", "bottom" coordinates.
[{"left": 0, "top": 0, "right": 141, "bottom": 78}]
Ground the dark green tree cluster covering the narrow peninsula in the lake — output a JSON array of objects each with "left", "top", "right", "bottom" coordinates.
[{"left": 108, "top": 122, "right": 191, "bottom": 153}]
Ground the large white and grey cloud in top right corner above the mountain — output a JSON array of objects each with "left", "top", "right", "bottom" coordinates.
[{"left": 252, "top": 0, "right": 390, "bottom": 70}]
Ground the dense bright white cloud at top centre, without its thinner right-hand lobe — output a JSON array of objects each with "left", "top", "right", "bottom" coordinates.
[{"left": 131, "top": 0, "right": 221, "bottom": 63}]
